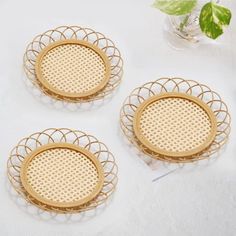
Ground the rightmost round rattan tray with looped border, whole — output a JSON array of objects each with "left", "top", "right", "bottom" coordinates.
[{"left": 121, "top": 78, "right": 230, "bottom": 162}]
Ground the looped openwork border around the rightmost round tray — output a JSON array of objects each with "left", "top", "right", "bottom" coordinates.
[{"left": 120, "top": 78, "right": 231, "bottom": 163}]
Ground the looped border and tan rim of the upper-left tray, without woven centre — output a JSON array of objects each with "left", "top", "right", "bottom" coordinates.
[{"left": 24, "top": 26, "right": 123, "bottom": 103}]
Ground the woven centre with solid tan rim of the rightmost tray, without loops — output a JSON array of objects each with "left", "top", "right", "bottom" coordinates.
[{"left": 133, "top": 93, "right": 216, "bottom": 157}]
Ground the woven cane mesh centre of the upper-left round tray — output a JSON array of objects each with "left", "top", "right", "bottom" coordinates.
[{"left": 40, "top": 44, "right": 106, "bottom": 94}]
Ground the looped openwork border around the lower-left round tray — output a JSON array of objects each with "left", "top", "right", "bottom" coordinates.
[{"left": 7, "top": 128, "right": 117, "bottom": 213}]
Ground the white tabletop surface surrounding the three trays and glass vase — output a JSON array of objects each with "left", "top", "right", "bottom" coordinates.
[{"left": 0, "top": 0, "right": 236, "bottom": 236}]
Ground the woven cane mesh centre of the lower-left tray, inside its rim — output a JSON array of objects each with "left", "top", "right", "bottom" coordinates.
[{"left": 23, "top": 148, "right": 99, "bottom": 203}]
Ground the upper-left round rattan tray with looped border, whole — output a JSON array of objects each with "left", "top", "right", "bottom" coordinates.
[{"left": 24, "top": 26, "right": 123, "bottom": 102}]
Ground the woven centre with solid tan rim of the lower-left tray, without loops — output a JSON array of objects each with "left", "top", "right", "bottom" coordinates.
[{"left": 20, "top": 143, "right": 104, "bottom": 208}]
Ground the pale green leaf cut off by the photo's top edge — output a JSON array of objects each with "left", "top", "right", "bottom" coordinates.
[{"left": 153, "top": 0, "right": 197, "bottom": 16}]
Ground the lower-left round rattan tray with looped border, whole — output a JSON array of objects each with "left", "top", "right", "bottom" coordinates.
[{"left": 8, "top": 129, "right": 117, "bottom": 213}]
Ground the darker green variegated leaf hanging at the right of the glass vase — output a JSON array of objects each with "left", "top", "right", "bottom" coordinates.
[{"left": 199, "top": 2, "right": 231, "bottom": 39}]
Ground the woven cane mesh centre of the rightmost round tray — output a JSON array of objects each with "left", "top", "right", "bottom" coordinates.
[{"left": 136, "top": 98, "right": 211, "bottom": 152}]
